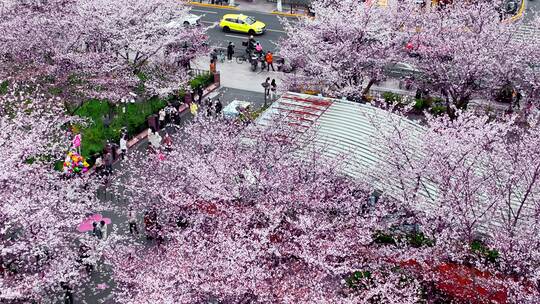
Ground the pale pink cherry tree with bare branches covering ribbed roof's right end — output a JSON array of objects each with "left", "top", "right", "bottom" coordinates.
[{"left": 379, "top": 112, "right": 540, "bottom": 303}]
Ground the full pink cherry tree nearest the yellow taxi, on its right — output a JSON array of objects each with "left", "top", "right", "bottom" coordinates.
[{"left": 279, "top": 1, "right": 408, "bottom": 96}]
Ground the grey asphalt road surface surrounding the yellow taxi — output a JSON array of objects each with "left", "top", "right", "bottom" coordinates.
[{"left": 191, "top": 6, "right": 296, "bottom": 52}]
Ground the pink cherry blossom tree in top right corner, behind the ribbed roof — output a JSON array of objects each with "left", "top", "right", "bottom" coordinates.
[{"left": 400, "top": 1, "right": 540, "bottom": 113}]
